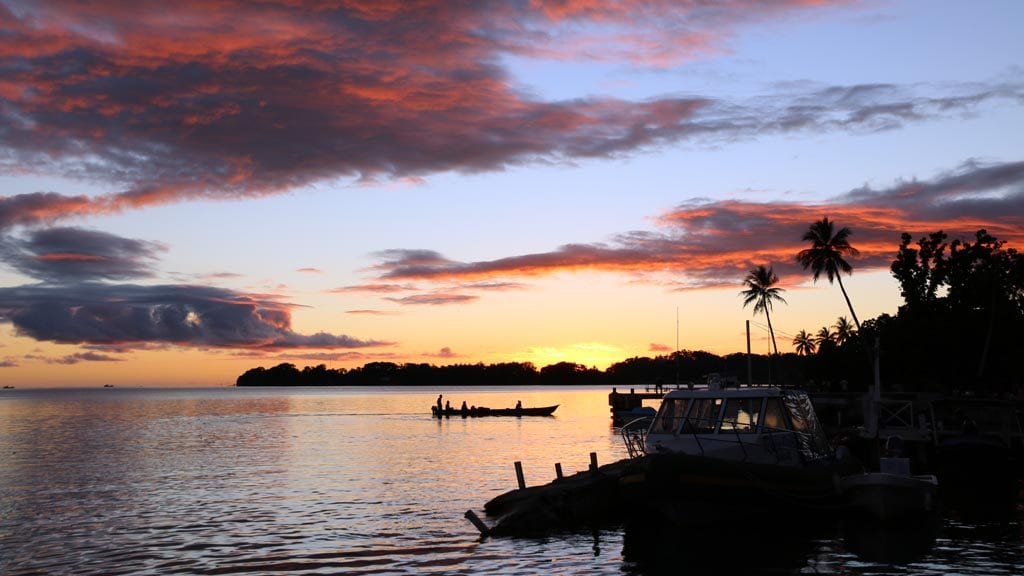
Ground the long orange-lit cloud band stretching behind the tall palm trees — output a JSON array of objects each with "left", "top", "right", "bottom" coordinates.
[{"left": 366, "top": 161, "right": 1024, "bottom": 289}]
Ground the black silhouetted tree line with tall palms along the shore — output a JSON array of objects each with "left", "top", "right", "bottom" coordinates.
[{"left": 237, "top": 224, "right": 1024, "bottom": 395}]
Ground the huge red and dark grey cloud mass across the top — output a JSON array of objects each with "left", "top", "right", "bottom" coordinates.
[{"left": 0, "top": 0, "right": 1024, "bottom": 229}]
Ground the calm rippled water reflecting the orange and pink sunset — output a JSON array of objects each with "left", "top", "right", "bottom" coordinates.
[{"left": 0, "top": 388, "right": 1024, "bottom": 575}]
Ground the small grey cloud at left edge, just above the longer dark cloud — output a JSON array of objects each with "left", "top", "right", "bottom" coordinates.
[{"left": 0, "top": 228, "right": 164, "bottom": 283}]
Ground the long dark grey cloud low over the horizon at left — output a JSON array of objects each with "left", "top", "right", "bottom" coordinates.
[{"left": 0, "top": 283, "right": 388, "bottom": 349}]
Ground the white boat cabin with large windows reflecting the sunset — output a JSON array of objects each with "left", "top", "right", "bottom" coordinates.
[{"left": 643, "top": 386, "right": 834, "bottom": 466}]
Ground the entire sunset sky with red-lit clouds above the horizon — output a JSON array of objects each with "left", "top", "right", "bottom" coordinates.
[{"left": 0, "top": 0, "right": 1024, "bottom": 387}]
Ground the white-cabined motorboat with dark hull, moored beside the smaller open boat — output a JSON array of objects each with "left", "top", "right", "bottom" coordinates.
[{"left": 623, "top": 381, "right": 862, "bottom": 523}]
